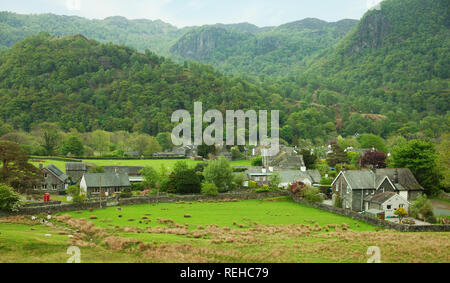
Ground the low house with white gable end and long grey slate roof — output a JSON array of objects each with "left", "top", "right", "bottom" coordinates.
[{"left": 80, "top": 173, "right": 131, "bottom": 197}]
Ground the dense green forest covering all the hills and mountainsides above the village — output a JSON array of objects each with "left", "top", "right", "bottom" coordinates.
[{"left": 0, "top": 0, "right": 450, "bottom": 149}]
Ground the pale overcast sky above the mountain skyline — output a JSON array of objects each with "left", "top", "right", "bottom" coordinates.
[{"left": 0, "top": 0, "right": 381, "bottom": 27}]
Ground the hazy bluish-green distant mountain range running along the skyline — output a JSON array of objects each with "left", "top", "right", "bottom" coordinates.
[{"left": 0, "top": 12, "right": 357, "bottom": 76}]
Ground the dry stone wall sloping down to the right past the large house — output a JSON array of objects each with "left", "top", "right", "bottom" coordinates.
[{"left": 292, "top": 196, "right": 450, "bottom": 232}]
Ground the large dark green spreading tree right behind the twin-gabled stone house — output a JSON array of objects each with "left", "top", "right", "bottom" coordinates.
[{"left": 389, "top": 140, "right": 442, "bottom": 195}]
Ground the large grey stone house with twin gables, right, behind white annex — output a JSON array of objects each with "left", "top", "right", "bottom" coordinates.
[{"left": 332, "top": 168, "right": 424, "bottom": 212}]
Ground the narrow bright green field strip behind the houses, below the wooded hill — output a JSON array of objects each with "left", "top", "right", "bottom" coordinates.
[{"left": 32, "top": 159, "right": 251, "bottom": 172}]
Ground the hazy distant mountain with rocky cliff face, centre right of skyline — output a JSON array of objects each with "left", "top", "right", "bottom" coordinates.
[{"left": 170, "top": 19, "right": 357, "bottom": 76}]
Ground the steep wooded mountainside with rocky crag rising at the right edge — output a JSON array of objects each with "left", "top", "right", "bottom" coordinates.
[{"left": 298, "top": 0, "right": 450, "bottom": 137}]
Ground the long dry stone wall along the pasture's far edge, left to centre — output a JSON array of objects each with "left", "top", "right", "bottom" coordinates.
[{"left": 0, "top": 192, "right": 289, "bottom": 217}]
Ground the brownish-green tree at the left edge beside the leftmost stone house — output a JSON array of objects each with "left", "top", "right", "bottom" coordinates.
[{"left": 0, "top": 141, "right": 42, "bottom": 190}]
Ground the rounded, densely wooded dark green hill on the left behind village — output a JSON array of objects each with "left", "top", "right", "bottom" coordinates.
[{"left": 0, "top": 33, "right": 269, "bottom": 135}]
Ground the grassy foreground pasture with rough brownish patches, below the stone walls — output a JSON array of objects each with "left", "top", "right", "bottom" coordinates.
[{"left": 0, "top": 198, "right": 450, "bottom": 263}]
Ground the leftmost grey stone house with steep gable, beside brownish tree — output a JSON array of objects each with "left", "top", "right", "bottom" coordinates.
[{"left": 33, "top": 165, "right": 70, "bottom": 193}]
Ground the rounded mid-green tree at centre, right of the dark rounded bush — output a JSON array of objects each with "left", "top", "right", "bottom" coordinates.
[{"left": 203, "top": 156, "right": 233, "bottom": 192}]
